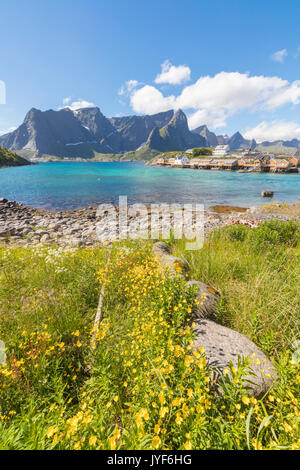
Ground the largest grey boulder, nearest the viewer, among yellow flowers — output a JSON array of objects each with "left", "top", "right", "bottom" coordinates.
[{"left": 193, "top": 319, "right": 277, "bottom": 397}]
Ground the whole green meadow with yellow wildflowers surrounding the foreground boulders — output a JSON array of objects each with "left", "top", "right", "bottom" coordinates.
[{"left": 0, "top": 222, "right": 300, "bottom": 449}]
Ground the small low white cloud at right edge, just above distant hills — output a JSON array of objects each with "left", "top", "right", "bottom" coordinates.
[{"left": 243, "top": 121, "right": 300, "bottom": 142}]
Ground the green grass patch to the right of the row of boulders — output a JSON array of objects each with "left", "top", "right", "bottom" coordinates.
[{"left": 171, "top": 221, "right": 300, "bottom": 358}]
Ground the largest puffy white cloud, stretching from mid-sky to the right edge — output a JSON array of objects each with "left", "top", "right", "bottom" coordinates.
[{"left": 130, "top": 72, "right": 300, "bottom": 129}]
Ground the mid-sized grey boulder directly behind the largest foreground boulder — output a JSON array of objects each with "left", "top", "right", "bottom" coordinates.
[{"left": 186, "top": 281, "right": 220, "bottom": 319}]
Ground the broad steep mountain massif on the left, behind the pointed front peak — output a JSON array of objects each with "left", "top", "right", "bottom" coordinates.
[{"left": 0, "top": 107, "right": 174, "bottom": 156}]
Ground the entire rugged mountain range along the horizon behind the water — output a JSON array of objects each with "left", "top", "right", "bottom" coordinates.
[{"left": 0, "top": 107, "right": 300, "bottom": 159}]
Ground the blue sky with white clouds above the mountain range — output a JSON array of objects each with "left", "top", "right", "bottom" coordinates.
[{"left": 0, "top": 0, "right": 300, "bottom": 140}]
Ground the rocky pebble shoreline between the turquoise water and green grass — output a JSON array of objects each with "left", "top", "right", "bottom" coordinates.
[{"left": 0, "top": 198, "right": 300, "bottom": 247}]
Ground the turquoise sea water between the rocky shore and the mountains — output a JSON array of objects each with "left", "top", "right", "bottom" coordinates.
[{"left": 0, "top": 162, "right": 300, "bottom": 210}]
